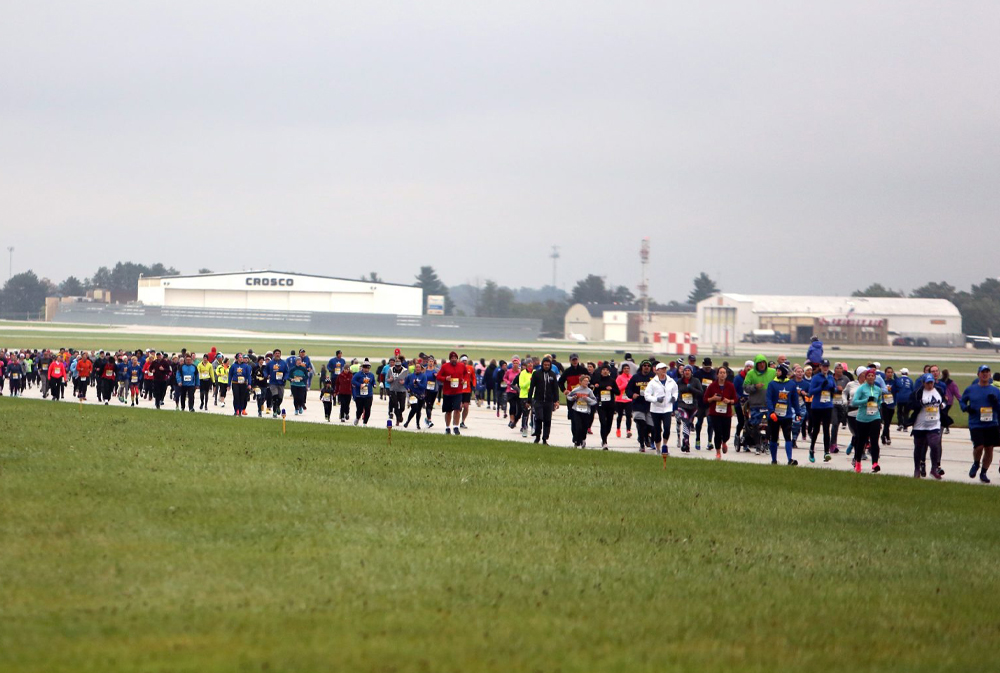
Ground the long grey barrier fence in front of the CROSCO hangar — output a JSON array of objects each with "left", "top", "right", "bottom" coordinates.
[{"left": 55, "top": 303, "right": 542, "bottom": 341}]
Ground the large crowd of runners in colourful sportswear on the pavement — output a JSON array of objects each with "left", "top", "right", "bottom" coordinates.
[{"left": 0, "top": 340, "right": 1000, "bottom": 483}]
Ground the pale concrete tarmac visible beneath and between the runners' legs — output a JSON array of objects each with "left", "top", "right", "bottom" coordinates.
[{"left": 11, "top": 378, "right": 1000, "bottom": 485}]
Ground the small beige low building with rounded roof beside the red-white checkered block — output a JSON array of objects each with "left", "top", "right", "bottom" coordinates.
[{"left": 563, "top": 304, "right": 696, "bottom": 343}]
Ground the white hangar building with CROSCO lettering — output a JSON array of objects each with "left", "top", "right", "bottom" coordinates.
[{"left": 138, "top": 271, "right": 423, "bottom": 315}]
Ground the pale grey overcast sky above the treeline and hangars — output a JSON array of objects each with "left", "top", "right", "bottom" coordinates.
[{"left": 0, "top": 0, "right": 1000, "bottom": 301}]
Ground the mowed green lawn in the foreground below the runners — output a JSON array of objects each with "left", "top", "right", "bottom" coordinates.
[{"left": 0, "top": 397, "right": 1000, "bottom": 672}]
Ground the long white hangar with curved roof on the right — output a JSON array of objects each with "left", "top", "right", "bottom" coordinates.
[{"left": 697, "top": 292, "right": 965, "bottom": 346}]
